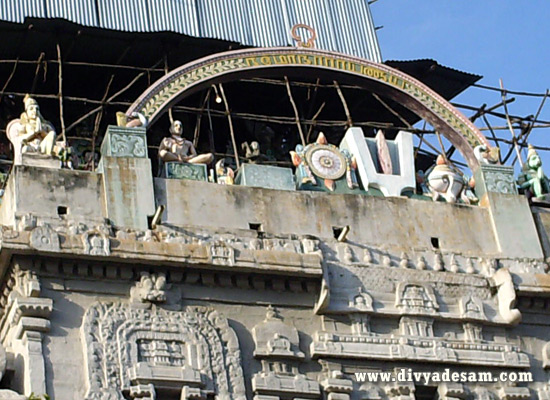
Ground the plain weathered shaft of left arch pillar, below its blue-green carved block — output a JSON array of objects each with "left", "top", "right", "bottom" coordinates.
[{"left": 101, "top": 157, "right": 155, "bottom": 230}]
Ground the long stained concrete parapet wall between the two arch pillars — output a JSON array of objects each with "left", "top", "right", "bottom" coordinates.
[{"left": 155, "top": 178, "right": 500, "bottom": 255}]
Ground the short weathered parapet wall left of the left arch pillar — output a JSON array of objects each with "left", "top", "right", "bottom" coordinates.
[{"left": 0, "top": 165, "right": 103, "bottom": 226}]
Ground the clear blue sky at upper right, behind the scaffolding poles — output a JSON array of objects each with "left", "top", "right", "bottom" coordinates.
[{"left": 371, "top": 0, "right": 550, "bottom": 168}]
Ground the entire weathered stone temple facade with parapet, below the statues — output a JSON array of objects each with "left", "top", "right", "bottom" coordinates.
[{"left": 0, "top": 163, "right": 550, "bottom": 400}]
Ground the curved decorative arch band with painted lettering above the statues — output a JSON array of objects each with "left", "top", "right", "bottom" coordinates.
[{"left": 126, "top": 47, "right": 491, "bottom": 170}]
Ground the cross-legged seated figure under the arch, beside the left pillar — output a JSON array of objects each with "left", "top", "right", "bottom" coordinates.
[{"left": 159, "top": 121, "right": 214, "bottom": 164}]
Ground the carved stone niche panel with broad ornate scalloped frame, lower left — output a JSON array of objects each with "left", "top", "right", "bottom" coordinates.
[{"left": 81, "top": 303, "right": 245, "bottom": 400}]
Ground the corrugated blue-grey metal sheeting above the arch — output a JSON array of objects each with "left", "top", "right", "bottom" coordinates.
[{"left": 0, "top": 0, "right": 382, "bottom": 62}]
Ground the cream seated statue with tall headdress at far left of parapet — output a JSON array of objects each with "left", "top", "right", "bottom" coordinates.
[{"left": 6, "top": 95, "right": 56, "bottom": 164}]
